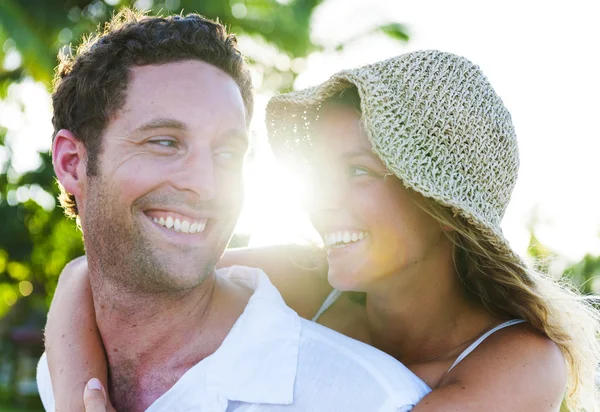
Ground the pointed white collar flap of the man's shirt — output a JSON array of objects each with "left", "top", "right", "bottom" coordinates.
[{"left": 207, "top": 267, "right": 301, "bottom": 405}]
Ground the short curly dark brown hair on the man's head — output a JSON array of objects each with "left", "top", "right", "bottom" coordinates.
[{"left": 52, "top": 9, "right": 254, "bottom": 218}]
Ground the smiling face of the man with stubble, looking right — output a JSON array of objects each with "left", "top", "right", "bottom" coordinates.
[{"left": 80, "top": 60, "right": 248, "bottom": 292}]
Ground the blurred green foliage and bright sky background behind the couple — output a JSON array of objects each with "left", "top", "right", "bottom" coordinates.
[{"left": 0, "top": 0, "right": 600, "bottom": 411}]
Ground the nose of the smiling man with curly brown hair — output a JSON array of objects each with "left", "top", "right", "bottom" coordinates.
[{"left": 173, "top": 150, "right": 217, "bottom": 201}]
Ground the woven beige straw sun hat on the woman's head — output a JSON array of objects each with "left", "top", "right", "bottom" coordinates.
[{"left": 267, "top": 50, "right": 521, "bottom": 262}]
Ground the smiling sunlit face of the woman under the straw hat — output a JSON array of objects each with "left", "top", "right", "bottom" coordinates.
[{"left": 308, "top": 104, "right": 447, "bottom": 291}]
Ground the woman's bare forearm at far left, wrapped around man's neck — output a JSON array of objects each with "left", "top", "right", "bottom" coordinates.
[{"left": 46, "top": 257, "right": 113, "bottom": 412}]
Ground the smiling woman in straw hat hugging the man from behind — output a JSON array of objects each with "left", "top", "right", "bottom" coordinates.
[{"left": 47, "top": 51, "right": 600, "bottom": 412}]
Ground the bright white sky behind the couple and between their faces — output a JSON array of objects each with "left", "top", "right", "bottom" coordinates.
[{"left": 0, "top": 0, "right": 600, "bottom": 260}]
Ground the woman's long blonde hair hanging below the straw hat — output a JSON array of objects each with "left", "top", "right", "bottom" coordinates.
[{"left": 416, "top": 196, "right": 600, "bottom": 412}]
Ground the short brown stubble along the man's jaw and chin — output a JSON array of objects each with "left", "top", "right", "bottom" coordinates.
[{"left": 83, "top": 182, "right": 217, "bottom": 295}]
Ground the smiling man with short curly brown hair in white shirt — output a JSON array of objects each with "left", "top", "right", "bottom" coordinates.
[{"left": 38, "top": 11, "right": 428, "bottom": 412}]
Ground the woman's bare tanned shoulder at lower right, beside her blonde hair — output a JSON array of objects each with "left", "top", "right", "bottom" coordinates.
[{"left": 440, "top": 323, "right": 567, "bottom": 410}]
